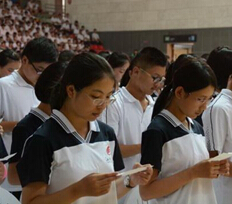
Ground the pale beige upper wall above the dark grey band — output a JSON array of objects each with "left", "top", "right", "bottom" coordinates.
[{"left": 66, "top": 0, "right": 232, "bottom": 31}]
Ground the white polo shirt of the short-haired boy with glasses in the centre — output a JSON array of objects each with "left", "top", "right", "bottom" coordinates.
[{"left": 100, "top": 87, "right": 154, "bottom": 170}]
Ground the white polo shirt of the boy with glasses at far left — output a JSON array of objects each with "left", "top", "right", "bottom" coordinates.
[{"left": 0, "top": 71, "right": 39, "bottom": 191}]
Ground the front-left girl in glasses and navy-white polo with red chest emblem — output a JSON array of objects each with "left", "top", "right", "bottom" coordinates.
[{"left": 17, "top": 53, "right": 152, "bottom": 204}]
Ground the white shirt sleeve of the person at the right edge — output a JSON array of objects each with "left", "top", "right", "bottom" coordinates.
[{"left": 202, "top": 106, "right": 228, "bottom": 153}]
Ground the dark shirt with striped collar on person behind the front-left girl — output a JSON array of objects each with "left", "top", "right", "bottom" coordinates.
[{"left": 9, "top": 108, "right": 49, "bottom": 163}]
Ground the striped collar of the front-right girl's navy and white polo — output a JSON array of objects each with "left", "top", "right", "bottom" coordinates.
[{"left": 159, "top": 109, "right": 194, "bottom": 132}]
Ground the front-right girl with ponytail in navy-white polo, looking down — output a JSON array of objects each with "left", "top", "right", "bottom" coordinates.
[{"left": 140, "top": 58, "right": 229, "bottom": 204}]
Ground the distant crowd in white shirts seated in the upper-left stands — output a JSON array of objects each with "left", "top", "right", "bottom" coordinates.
[{"left": 0, "top": 0, "right": 104, "bottom": 53}]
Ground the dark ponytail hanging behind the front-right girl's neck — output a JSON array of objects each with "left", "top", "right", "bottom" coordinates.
[{"left": 152, "top": 83, "right": 173, "bottom": 119}]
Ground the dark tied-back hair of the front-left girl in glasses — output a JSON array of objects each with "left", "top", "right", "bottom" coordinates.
[{"left": 51, "top": 53, "right": 115, "bottom": 110}]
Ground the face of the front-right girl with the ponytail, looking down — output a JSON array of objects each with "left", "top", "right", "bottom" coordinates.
[{"left": 175, "top": 85, "right": 215, "bottom": 119}]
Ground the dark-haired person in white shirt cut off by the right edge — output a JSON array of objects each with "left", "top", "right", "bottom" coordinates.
[{"left": 202, "top": 47, "right": 232, "bottom": 204}]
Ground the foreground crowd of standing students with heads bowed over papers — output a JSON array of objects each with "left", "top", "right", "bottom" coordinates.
[{"left": 0, "top": 2, "right": 232, "bottom": 204}]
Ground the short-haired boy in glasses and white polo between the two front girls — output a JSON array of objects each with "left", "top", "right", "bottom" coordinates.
[{"left": 100, "top": 47, "right": 167, "bottom": 170}]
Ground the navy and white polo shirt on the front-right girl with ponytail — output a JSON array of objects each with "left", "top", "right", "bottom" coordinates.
[{"left": 141, "top": 110, "right": 216, "bottom": 204}]
